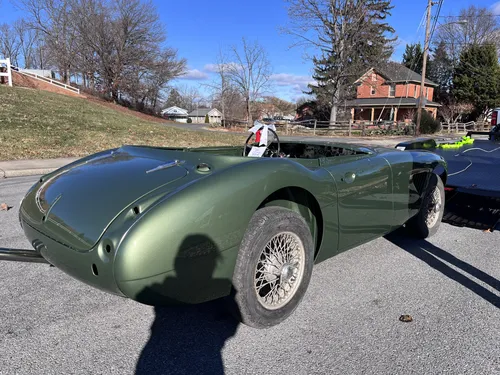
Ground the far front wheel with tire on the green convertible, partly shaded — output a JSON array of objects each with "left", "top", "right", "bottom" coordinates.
[{"left": 406, "top": 173, "right": 445, "bottom": 239}]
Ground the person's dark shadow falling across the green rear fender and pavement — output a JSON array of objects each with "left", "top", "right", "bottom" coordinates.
[{"left": 136, "top": 235, "right": 239, "bottom": 375}]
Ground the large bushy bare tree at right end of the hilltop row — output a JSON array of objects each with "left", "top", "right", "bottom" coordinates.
[{"left": 70, "top": 0, "right": 186, "bottom": 102}]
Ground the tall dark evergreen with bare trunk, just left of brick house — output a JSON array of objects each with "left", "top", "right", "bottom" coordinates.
[{"left": 293, "top": 0, "right": 394, "bottom": 122}]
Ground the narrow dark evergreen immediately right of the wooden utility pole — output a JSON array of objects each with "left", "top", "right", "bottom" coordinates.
[{"left": 428, "top": 41, "right": 453, "bottom": 104}]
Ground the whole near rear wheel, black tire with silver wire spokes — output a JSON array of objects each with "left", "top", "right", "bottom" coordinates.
[{"left": 230, "top": 207, "right": 314, "bottom": 328}]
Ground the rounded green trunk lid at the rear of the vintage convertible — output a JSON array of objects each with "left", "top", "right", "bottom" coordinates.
[{"left": 21, "top": 149, "right": 188, "bottom": 250}]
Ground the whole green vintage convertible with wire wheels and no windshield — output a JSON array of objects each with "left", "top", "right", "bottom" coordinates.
[{"left": 0, "top": 124, "right": 447, "bottom": 328}]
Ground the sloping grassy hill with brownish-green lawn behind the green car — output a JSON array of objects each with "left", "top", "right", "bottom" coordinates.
[{"left": 0, "top": 86, "right": 244, "bottom": 160}]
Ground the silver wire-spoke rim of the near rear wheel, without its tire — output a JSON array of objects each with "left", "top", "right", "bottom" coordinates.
[{"left": 254, "top": 232, "right": 305, "bottom": 310}]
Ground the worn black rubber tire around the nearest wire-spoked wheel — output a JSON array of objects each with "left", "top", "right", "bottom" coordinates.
[{"left": 230, "top": 207, "right": 314, "bottom": 328}]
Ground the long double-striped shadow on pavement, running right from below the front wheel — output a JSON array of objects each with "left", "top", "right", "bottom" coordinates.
[{"left": 385, "top": 229, "right": 500, "bottom": 308}]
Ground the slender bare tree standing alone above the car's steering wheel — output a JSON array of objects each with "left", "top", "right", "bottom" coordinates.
[{"left": 227, "top": 38, "right": 271, "bottom": 125}]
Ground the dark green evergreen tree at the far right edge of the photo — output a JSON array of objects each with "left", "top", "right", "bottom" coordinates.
[{"left": 452, "top": 44, "right": 500, "bottom": 118}]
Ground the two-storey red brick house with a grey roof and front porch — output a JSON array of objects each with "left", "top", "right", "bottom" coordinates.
[{"left": 346, "top": 61, "right": 440, "bottom": 122}]
